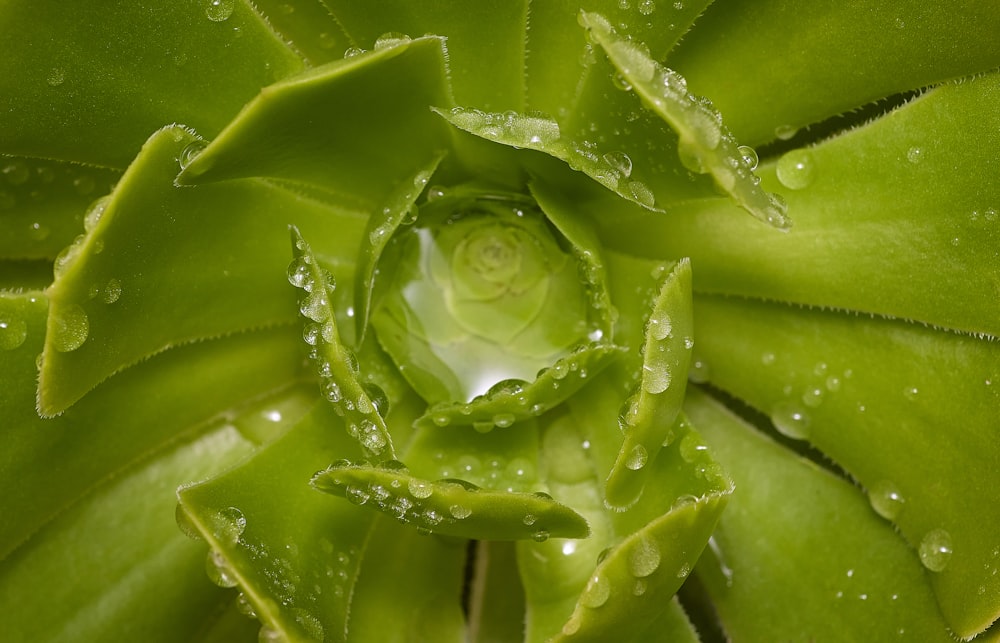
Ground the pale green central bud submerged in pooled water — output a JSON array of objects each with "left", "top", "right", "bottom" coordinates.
[{"left": 372, "top": 190, "right": 590, "bottom": 403}]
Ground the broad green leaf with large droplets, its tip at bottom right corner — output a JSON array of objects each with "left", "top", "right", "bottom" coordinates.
[{"left": 695, "top": 297, "right": 1000, "bottom": 637}]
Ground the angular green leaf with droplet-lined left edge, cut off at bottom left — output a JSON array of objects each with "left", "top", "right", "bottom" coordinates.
[{"left": 178, "top": 404, "right": 371, "bottom": 641}]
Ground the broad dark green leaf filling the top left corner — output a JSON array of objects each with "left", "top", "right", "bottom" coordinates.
[{"left": 0, "top": 0, "right": 302, "bottom": 169}]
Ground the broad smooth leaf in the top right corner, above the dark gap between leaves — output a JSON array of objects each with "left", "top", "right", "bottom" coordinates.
[{"left": 670, "top": 0, "right": 1000, "bottom": 145}]
